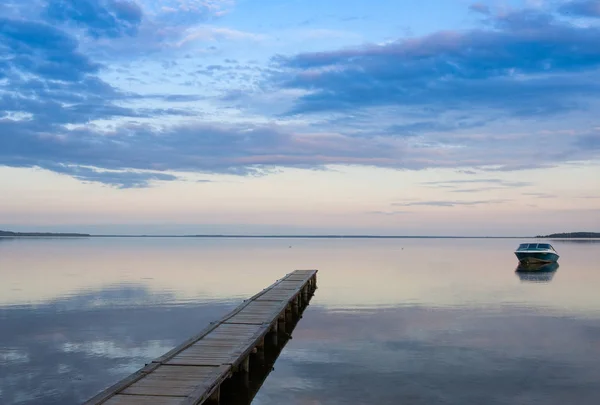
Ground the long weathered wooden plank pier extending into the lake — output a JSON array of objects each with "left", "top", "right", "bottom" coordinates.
[{"left": 84, "top": 270, "right": 317, "bottom": 405}]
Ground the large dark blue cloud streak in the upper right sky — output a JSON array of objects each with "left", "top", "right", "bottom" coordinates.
[{"left": 270, "top": 10, "right": 600, "bottom": 118}]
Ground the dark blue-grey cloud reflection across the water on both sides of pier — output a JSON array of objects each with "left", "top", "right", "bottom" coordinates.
[{"left": 0, "top": 286, "right": 600, "bottom": 405}]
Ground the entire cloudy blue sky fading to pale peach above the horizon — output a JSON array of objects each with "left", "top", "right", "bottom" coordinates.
[{"left": 0, "top": 0, "right": 600, "bottom": 236}]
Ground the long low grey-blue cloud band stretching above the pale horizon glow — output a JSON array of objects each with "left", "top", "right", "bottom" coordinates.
[{"left": 0, "top": 111, "right": 596, "bottom": 189}]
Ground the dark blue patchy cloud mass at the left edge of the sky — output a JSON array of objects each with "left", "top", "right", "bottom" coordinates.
[{"left": 0, "top": 11, "right": 202, "bottom": 187}]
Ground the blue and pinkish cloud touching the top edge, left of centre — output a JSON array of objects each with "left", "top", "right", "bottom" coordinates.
[{"left": 32, "top": 0, "right": 235, "bottom": 62}]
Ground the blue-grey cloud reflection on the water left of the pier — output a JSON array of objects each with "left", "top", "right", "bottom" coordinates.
[{"left": 0, "top": 285, "right": 234, "bottom": 405}]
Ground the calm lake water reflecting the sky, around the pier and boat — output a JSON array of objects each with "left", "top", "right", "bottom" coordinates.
[{"left": 0, "top": 238, "right": 600, "bottom": 405}]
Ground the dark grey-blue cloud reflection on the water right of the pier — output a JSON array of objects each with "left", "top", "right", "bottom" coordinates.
[{"left": 255, "top": 307, "right": 600, "bottom": 405}]
